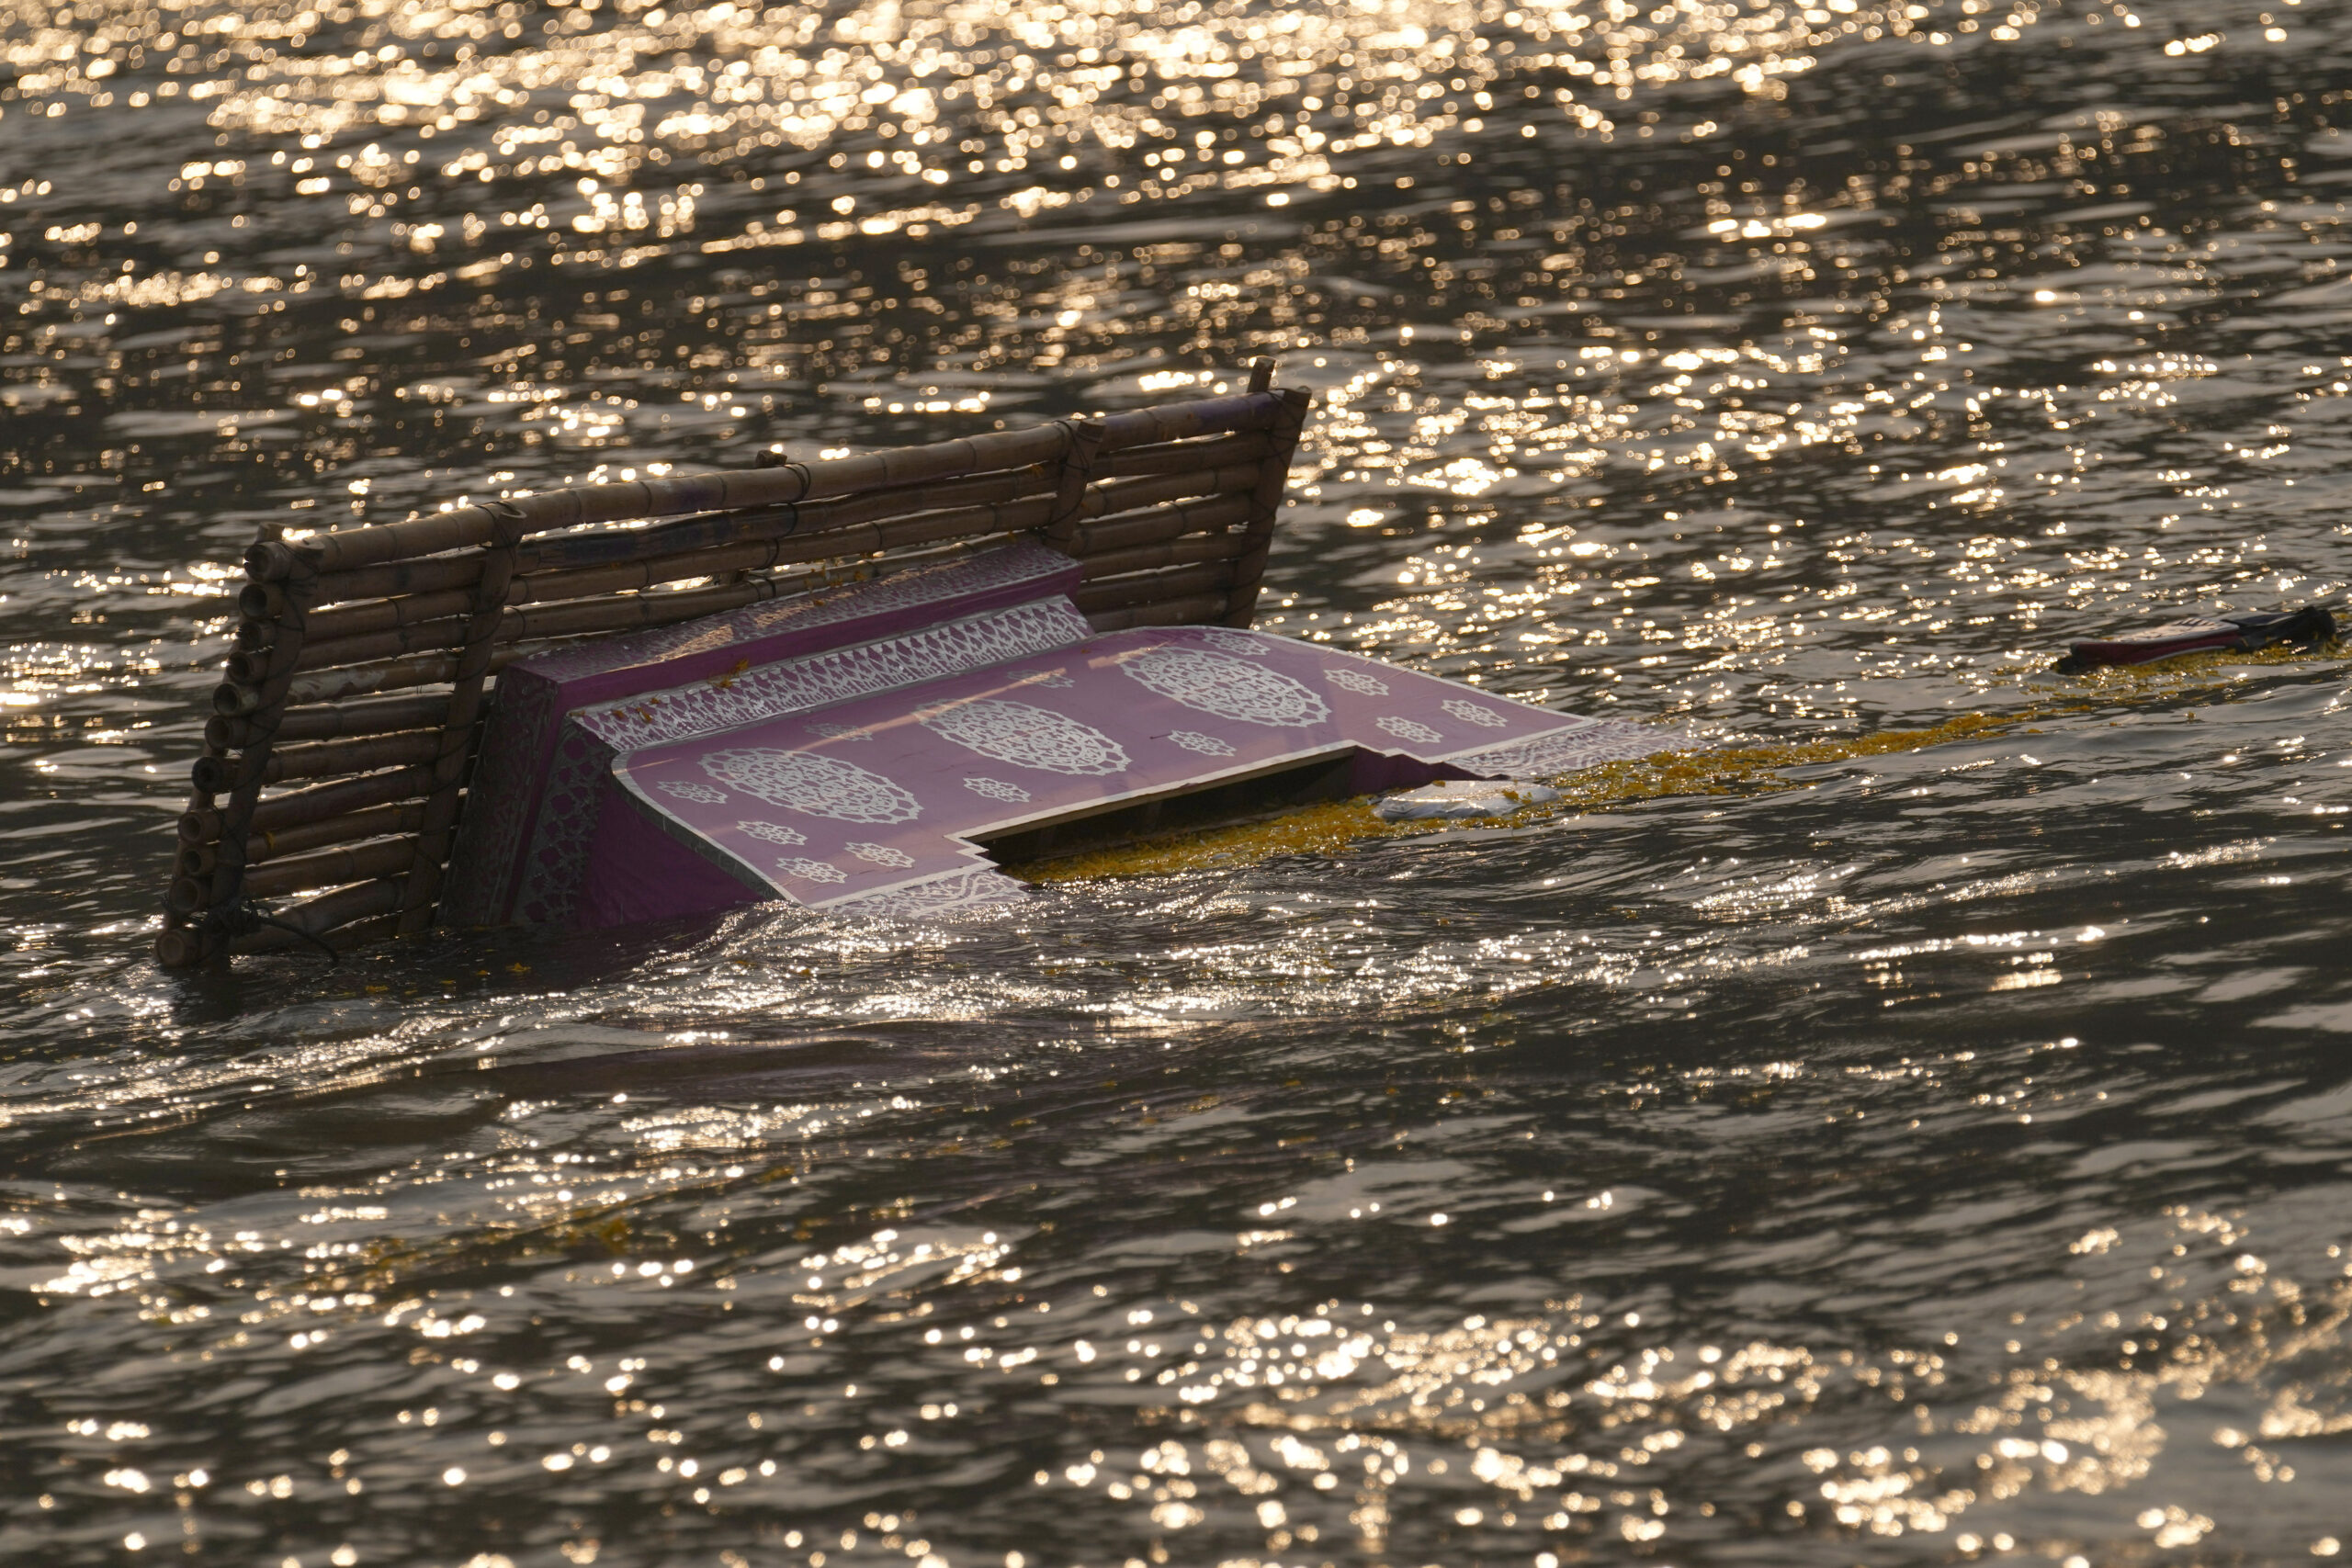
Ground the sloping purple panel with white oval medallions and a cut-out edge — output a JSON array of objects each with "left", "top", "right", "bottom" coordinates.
[{"left": 588, "top": 627, "right": 1660, "bottom": 926}]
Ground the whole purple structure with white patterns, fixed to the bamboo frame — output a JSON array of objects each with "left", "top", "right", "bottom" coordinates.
[{"left": 445, "top": 541, "right": 1660, "bottom": 926}]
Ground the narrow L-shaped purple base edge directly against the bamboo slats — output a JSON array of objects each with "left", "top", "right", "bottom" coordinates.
[{"left": 442, "top": 541, "right": 1080, "bottom": 926}]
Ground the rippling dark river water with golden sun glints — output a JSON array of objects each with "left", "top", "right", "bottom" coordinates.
[{"left": 0, "top": 0, "right": 2352, "bottom": 1568}]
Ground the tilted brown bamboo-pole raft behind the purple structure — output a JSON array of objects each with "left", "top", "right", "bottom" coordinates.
[{"left": 155, "top": 360, "right": 1310, "bottom": 968}]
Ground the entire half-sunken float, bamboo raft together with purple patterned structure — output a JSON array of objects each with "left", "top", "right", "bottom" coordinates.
[{"left": 155, "top": 376, "right": 1656, "bottom": 966}]
